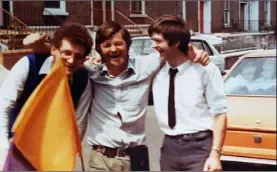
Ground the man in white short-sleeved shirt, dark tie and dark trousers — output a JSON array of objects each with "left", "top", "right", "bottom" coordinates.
[{"left": 148, "top": 15, "right": 227, "bottom": 171}]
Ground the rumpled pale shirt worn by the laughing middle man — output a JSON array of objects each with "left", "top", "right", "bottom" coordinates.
[{"left": 85, "top": 53, "right": 161, "bottom": 148}]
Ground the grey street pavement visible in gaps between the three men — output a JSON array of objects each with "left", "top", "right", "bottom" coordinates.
[{"left": 76, "top": 106, "right": 164, "bottom": 171}]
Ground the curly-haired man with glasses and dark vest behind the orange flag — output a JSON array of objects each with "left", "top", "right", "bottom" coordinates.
[{"left": 0, "top": 23, "right": 92, "bottom": 170}]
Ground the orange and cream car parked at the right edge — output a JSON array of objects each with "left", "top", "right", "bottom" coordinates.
[{"left": 222, "top": 49, "right": 276, "bottom": 169}]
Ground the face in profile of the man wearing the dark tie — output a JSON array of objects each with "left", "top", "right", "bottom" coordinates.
[{"left": 151, "top": 33, "right": 176, "bottom": 59}]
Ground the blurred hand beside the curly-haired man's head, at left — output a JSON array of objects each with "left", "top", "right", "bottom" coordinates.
[{"left": 23, "top": 33, "right": 50, "bottom": 53}]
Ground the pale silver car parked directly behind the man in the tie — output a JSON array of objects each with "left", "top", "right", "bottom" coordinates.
[{"left": 130, "top": 35, "right": 225, "bottom": 74}]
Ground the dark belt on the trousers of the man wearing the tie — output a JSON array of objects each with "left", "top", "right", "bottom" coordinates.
[{"left": 165, "top": 130, "right": 213, "bottom": 141}]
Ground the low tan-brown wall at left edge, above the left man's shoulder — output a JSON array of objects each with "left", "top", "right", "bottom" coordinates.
[{"left": 0, "top": 49, "right": 32, "bottom": 70}]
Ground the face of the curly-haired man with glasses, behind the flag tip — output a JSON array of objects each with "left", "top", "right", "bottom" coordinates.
[{"left": 51, "top": 39, "right": 85, "bottom": 76}]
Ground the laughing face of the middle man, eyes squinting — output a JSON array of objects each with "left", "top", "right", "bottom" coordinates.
[{"left": 100, "top": 32, "right": 128, "bottom": 67}]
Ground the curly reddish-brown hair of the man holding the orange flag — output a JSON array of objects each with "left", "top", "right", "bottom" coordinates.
[{"left": 52, "top": 23, "right": 93, "bottom": 56}]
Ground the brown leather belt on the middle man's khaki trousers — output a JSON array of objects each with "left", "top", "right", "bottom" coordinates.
[{"left": 92, "top": 145, "right": 129, "bottom": 158}]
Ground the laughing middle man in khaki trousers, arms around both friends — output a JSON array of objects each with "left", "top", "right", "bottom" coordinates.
[{"left": 18, "top": 21, "right": 209, "bottom": 171}]
